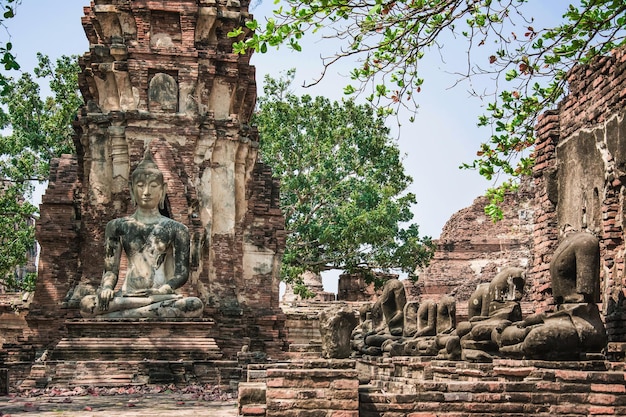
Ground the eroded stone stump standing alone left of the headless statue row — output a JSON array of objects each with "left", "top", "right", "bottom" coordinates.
[{"left": 319, "top": 307, "right": 358, "bottom": 359}]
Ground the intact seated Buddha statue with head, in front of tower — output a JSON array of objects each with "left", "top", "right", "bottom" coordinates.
[{"left": 80, "top": 150, "right": 204, "bottom": 318}]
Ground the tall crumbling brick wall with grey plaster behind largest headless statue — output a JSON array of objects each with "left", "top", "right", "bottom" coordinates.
[{"left": 532, "top": 49, "right": 626, "bottom": 342}]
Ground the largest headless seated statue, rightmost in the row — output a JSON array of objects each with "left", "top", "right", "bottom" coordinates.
[{"left": 500, "top": 232, "right": 607, "bottom": 360}]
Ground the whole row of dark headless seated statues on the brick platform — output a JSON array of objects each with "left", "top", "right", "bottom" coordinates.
[{"left": 351, "top": 232, "right": 607, "bottom": 362}]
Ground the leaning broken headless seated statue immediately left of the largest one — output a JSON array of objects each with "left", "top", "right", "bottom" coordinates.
[{"left": 456, "top": 267, "right": 525, "bottom": 362}]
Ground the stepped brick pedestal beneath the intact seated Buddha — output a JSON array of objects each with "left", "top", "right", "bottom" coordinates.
[{"left": 20, "top": 318, "right": 229, "bottom": 390}]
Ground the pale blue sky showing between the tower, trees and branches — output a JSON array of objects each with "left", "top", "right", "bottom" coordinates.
[{"left": 0, "top": 0, "right": 567, "bottom": 244}]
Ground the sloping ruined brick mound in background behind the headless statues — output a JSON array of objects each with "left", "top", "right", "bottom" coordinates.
[{"left": 416, "top": 180, "right": 536, "bottom": 320}]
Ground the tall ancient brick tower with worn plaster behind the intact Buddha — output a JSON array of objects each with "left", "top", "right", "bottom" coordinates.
[{"left": 29, "top": 0, "right": 285, "bottom": 356}]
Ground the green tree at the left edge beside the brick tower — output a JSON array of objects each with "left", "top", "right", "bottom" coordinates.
[{"left": 0, "top": 54, "right": 82, "bottom": 289}]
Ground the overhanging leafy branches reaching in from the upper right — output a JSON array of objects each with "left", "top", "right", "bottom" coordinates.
[{"left": 230, "top": 0, "right": 626, "bottom": 218}]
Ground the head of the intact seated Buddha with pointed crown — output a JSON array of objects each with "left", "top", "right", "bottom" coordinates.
[{"left": 130, "top": 150, "right": 167, "bottom": 210}]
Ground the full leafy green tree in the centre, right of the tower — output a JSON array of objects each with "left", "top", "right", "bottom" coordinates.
[{"left": 253, "top": 70, "right": 434, "bottom": 293}]
